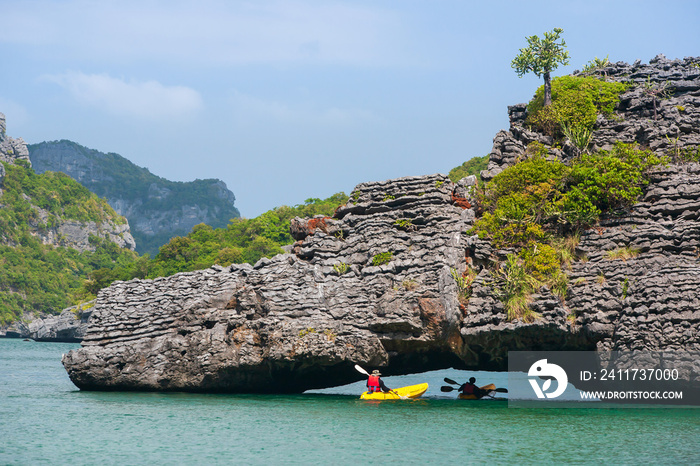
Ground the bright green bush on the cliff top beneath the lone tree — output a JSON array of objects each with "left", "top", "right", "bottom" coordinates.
[{"left": 526, "top": 76, "right": 627, "bottom": 137}]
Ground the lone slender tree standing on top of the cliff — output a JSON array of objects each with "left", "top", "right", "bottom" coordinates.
[{"left": 510, "top": 28, "right": 569, "bottom": 107}]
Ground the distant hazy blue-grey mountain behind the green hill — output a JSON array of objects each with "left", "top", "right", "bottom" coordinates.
[{"left": 28, "top": 140, "right": 240, "bottom": 256}]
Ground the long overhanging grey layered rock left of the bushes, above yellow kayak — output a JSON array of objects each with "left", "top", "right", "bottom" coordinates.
[{"left": 63, "top": 175, "right": 473, "bottom": 392}]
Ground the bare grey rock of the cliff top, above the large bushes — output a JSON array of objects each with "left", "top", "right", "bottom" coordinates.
[{"left": 482, "top": 55, "right": 700, "bottom": 180}]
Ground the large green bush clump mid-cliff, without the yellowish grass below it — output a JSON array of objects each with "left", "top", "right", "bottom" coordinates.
[{"left": 472, "top": 143, "right": 666, "bottom": 240}]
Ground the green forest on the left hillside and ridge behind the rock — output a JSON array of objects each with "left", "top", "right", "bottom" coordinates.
[{"left": 0, "top": 160, "right": 347, "bottom": 324}]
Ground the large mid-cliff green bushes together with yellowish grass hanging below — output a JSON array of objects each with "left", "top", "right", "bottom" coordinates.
[{"left": 471, "top": 144, "right": 665, "bottom": 321}]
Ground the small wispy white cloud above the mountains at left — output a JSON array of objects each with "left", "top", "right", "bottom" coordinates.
[{"left": 43, "top": 72, "right": 203, "bottom": 120}]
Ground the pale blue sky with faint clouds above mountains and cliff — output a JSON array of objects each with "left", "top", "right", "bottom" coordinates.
[{"left": 0, "top": 0, "right": 700, "bottom": 218}]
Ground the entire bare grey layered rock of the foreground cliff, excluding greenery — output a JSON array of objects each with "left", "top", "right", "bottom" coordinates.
[{"left": 63, "top": 57, "right": 700, "bottom": 392}]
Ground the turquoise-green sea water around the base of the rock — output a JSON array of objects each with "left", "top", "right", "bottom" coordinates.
[{"left": 0, "top": 339, "right": 700, "bottom": 465}]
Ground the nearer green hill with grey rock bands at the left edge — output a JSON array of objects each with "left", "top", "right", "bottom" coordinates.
[{"left": 0, "top": 113, "right": 138, "bottom": 326}]
